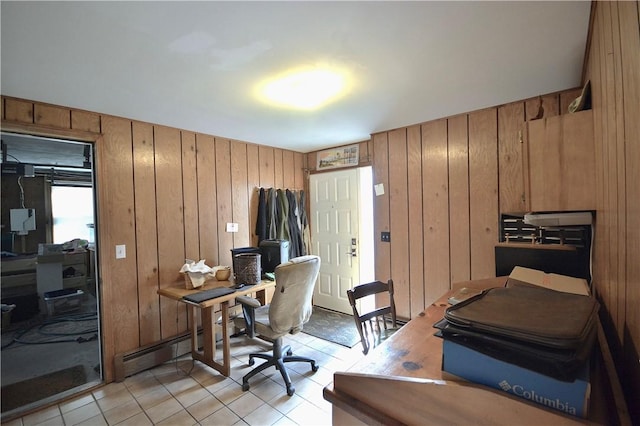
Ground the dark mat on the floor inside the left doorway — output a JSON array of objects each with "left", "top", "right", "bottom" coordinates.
[{"left": 0, "top": 365, "right": 87, "bottom": 413}]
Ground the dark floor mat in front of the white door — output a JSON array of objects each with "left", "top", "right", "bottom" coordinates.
[{"left": 302, "top": 306, "right": 360, "bottom": 348}]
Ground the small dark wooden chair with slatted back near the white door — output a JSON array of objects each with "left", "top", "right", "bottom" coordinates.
[{"left": 347, "top": 280, "right": 398, "bottom": 355}]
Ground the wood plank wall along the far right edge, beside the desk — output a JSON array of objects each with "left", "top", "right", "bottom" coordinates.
[{"left": 585, "top": 1, "right": 640, "bottom": 424}]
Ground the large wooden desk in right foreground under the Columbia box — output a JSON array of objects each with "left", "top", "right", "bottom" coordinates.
[{"left": 324, "top": 277, "right": 630, "bottom": 425}]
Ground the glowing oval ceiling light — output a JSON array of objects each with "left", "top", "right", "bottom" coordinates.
[{"left": 258, "top": 68, "right": 347, "bottom": 110}]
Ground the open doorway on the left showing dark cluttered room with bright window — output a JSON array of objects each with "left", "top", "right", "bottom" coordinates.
[{"left": 0, "top": 132, "right": 103, "bottom": 420}]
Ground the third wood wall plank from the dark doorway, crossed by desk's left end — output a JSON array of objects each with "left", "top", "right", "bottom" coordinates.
[{"left": 154, "top": 126, "right": 187, "bottom": 339}]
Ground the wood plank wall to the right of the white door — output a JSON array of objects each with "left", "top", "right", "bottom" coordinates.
[{"left": 308, "top": 88, "right": 580, "bottom": 319}]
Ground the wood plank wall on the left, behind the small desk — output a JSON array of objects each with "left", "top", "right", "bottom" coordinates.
[{"left": 0, "top": 97, "right": 306, "bottom": 381}]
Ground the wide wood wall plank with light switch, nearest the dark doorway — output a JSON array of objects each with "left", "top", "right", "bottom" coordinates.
[{"left": 96, "top": 116, "right": 139, "bottom": 381}]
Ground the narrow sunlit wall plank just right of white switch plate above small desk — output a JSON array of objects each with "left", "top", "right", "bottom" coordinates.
[{"left": 229, "top": 141, "right": 254, "bottom": 249}]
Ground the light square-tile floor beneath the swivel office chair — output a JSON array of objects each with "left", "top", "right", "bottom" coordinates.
[{"left": 4, "top": 333, "right": 364, "bottom": 426}]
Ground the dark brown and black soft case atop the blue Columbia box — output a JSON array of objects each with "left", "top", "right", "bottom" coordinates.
[{"left": 434, "top": 286, "right": 599, "bottom": 382}]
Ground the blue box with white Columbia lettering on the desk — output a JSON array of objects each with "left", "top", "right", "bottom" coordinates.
[{"left": 442, "top": 339, "right": 591, "bottom": 417}]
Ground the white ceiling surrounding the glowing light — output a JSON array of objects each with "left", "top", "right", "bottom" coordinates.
[{"left": 1, "top": 1, "right": 590, "bottom": 152}]
